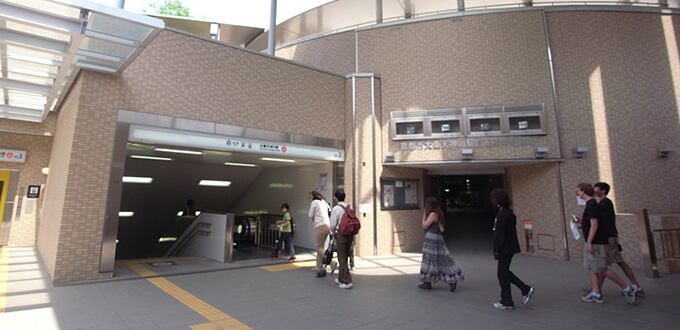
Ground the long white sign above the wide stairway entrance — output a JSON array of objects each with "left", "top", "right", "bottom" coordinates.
[{"left": 129, "top": 126, "right": 345, "bottom": 161}]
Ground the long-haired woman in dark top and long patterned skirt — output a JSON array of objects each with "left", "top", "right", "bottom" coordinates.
[{"left": 418, "top": 197, "right": 465, "bottom": 292}]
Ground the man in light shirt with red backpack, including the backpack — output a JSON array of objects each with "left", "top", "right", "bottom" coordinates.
[{"left": 330, "top": 189, "right": 360, "bottom": 289}]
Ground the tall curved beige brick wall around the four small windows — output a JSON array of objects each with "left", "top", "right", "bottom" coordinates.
[{"left": 277, "top": 7, "right": 680, "bottom": 266}]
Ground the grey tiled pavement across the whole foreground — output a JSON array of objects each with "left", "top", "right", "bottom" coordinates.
[{"left": 0, "top": 248, "right": 680, "bottom": 330}]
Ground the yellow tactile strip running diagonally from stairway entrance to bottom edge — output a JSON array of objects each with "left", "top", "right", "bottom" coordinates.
[{"left": 122, "top": 259, "right": 252, "bottom": 330}]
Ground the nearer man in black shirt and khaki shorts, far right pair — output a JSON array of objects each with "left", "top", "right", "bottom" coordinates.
[{"left": 576, "top": 182, "right": 636, "bottom": 304}]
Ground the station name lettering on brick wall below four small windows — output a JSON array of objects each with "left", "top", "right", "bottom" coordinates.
[{"left": 401, "top": 138, "right": 538, "bottom": 150}]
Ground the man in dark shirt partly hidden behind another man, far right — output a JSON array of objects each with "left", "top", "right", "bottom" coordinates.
[{"left": 593, "top": 182, "right": 645, "bottom": 297}]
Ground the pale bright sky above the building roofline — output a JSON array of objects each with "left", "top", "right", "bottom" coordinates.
[{"left": 89, "top": 0, "right": 332, "bottom": 29}]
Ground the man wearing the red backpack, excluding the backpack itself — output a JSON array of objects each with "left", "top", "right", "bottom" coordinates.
[{"left": 331, "top": 189, "right": 354, "bottom": 289}]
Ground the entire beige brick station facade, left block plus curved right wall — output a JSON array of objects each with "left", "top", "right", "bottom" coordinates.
[{"left": 0, "top": 9, "right": 680, "bottom": 282}]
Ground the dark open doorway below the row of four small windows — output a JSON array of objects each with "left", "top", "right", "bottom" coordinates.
[{"left": 430, "top": 174, "right": 504, "bottom": 253}]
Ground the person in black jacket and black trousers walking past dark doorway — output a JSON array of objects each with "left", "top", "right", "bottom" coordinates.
[{"left": 491, "top": 189, "right": 534, "bottom": 309}]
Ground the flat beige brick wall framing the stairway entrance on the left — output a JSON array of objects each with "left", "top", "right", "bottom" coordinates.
[{"left": 39, "top": 31, "right": 345, "bottom": 282}]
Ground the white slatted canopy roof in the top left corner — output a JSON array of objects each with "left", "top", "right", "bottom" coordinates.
[{"left": 0, "top": 0, "right": 165, "bottom": 122}]
